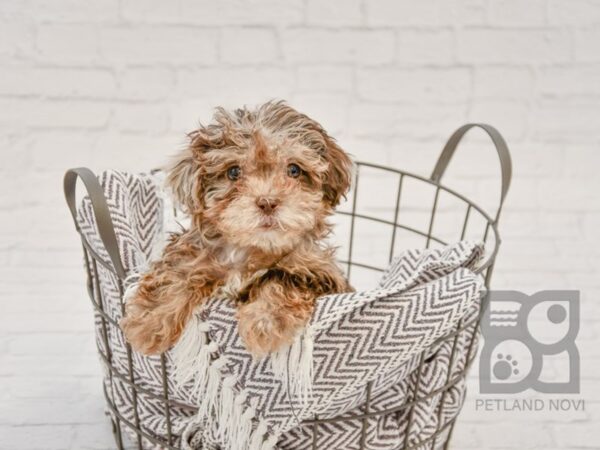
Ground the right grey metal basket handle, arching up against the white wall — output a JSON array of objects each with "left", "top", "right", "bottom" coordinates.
[{"left": 430, "top": 123, "right": 512, "bottom": 223}]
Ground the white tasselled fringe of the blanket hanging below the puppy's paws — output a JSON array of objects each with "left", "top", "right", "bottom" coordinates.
[{"left": 173, "top": 314, "right": 302, "bottom": 450}]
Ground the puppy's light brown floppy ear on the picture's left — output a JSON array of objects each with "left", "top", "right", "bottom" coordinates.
[{"left": 167, "top": 146, "right": 201, "bottom": 215}]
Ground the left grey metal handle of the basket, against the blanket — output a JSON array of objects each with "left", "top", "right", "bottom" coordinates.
[{"left": 63, "top": 167, "right": 125, "bottom": 278}]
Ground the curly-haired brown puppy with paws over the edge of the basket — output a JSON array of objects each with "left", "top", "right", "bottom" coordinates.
[{"left": 121, "top": 102, "right": 352, "bottom": 356}]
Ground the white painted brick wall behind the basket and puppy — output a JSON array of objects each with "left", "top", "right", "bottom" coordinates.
[{"left": 0, "top": 0, "right": 600, "bottom": 450}]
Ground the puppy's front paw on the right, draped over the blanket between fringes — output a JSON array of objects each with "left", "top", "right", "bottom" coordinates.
[{"left": 238, "top": 302, "right": 295, "bottom": 358}]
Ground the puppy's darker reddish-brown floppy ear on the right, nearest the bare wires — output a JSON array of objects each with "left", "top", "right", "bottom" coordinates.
[{"left": 323, "top": 133, "right": 352, "bottom": 207}]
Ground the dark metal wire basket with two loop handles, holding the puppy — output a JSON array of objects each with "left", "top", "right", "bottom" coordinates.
[{"left": 64, "top": 124, "right": 511, "bottom": 450}]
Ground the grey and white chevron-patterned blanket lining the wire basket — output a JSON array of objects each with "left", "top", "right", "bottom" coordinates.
[{"left": 78, "top": 171, "right": 483, "bottom": 450}]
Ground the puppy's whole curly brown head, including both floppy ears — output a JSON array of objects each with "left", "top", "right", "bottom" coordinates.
[{"left": 169, "top": 103, "right": 351, "bottom": 253}]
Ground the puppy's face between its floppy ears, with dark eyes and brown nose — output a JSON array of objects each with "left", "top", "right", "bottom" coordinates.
[{"left": 203, "top": 131, "right": 329, "bottom": 252}]
